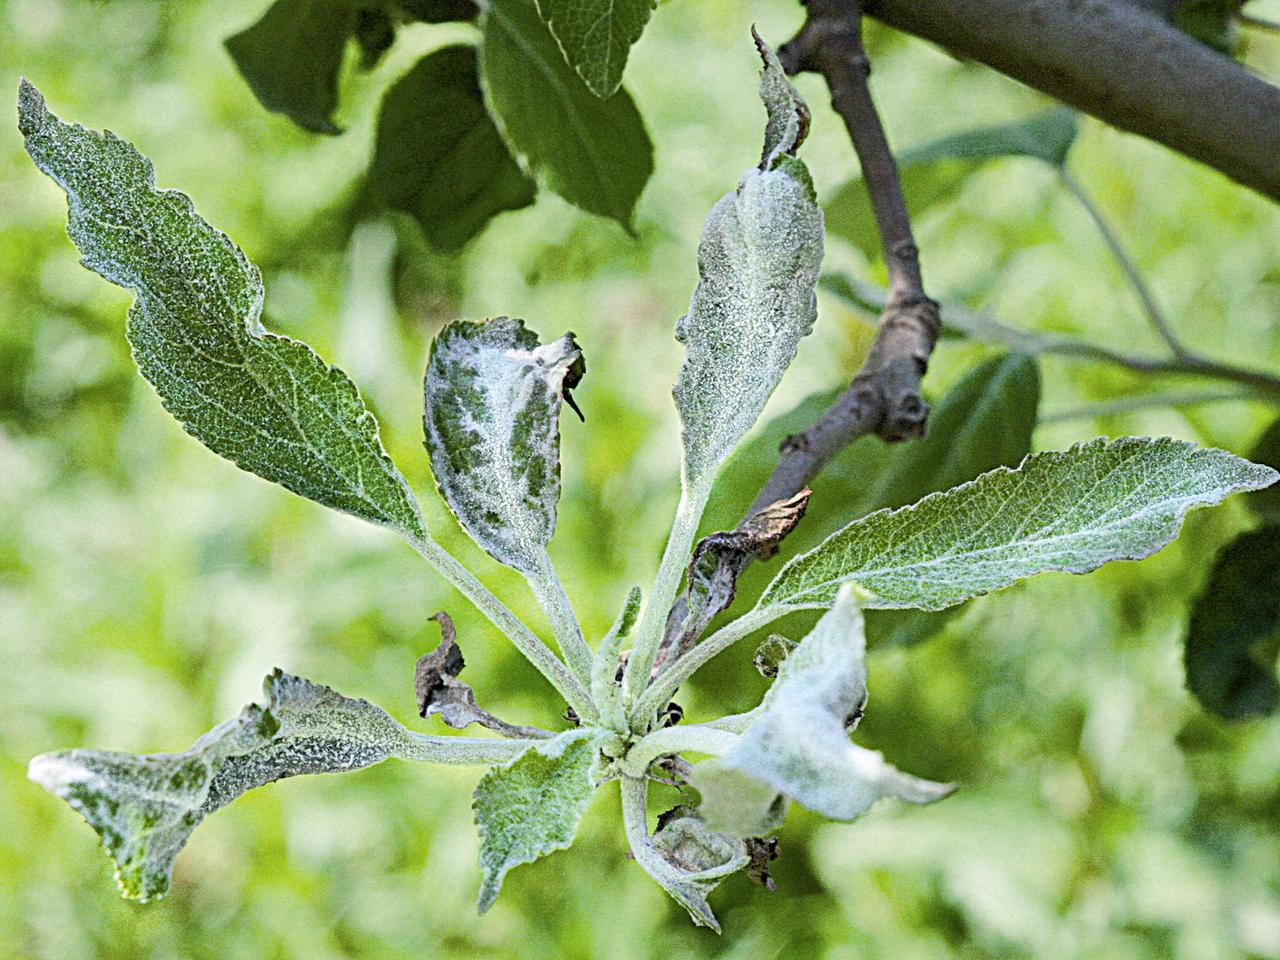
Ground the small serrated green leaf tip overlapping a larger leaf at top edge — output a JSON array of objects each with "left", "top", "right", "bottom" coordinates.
[{"left": 538, "top": 0, "right": 654, "bottom": 97}]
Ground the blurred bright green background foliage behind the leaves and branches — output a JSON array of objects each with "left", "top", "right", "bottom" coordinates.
[{"left": 0, "top": 0, "right": 1280, "bottom": 960}]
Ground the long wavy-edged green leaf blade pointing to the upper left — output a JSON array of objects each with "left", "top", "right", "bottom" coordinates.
[{"left": 18, "top": 81, "right": 425, "bottom": 538}]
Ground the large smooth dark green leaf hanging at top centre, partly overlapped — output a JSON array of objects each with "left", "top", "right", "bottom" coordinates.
[{"left": 480, "top": 0, "right": 653, "bottom": 230}]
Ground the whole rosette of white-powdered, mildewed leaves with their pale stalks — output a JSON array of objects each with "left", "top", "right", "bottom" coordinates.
[{"left": 19, "top": 39, "right": 1277, "bottom": 928}]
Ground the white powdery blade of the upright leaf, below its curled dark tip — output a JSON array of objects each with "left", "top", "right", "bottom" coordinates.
[{"left": 673, "top": 161, "right": 823, "bottom": 483}]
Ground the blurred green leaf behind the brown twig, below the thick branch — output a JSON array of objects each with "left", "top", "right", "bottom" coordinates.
[{"left": 826, "top": 106, "right": 1079, "bottom": 260}]
